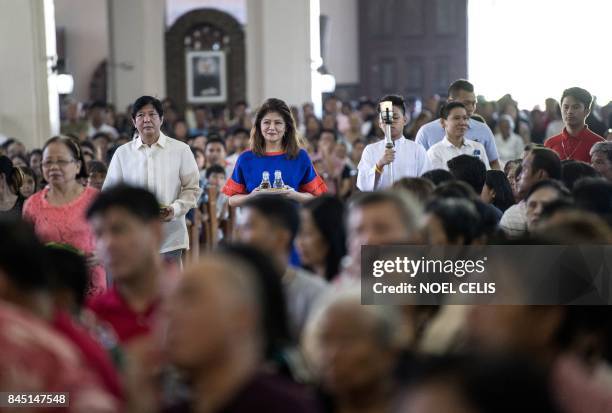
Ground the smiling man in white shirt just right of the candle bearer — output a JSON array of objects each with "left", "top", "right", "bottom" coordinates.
[{"left": 427, "top": 102, "right": 489, "bottom": 171}]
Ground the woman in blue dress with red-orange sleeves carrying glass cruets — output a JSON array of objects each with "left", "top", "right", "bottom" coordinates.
[{"left": 223, "top": 98, "right": 327, "bottom": 206}]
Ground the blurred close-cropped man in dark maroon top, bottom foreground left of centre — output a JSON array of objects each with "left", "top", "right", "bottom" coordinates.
[{"left": 166, "top": 254, "right": 316, "bottom": 413}]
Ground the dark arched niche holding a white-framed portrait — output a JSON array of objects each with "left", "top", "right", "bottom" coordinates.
[{"left": 166, "top": 9, "right": 246, "bottom": 109}]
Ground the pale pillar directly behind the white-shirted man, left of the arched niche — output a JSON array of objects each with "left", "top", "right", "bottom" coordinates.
[{"left": 108, "top": 0, "right": 166, "bottom": 110}]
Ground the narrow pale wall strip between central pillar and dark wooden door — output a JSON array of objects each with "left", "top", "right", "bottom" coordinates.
[{"left": 320, "top": 0, "right": 359, "bottom": 83}]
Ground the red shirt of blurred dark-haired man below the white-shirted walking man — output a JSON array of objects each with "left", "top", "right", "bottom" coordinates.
[{"left": 87, "top": 285, "right": 161, "bottom": 344}]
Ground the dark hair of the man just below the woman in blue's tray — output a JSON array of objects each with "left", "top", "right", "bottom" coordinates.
[{"left": 242, "top": 195, "right": 300, "bottom": 249}]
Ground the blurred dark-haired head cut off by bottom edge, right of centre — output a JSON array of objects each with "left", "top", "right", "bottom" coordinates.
[{"left": 397, "top": 354, "right": 560, "bottom": 413}]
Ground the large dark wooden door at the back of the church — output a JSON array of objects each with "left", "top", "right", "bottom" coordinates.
[{"left": 359, "top": 0, "right": 467, "bottom": 99}]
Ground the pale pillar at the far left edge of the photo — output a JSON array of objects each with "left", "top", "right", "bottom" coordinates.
[{"left": 0, "top": 0, "right": 59, "bottom": 149}]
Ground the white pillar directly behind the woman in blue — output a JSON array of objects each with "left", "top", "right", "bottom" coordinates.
[{"left": 246, "top": 0, "right": 319, "bottom": 107}]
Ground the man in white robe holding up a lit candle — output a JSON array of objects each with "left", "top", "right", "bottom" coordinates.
[{"left": 357, "top": 95, "right": 431, "bottom": 192}]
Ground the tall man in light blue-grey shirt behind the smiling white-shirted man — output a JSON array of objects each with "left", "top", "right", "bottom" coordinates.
[{"left": 415, "top": 79, "right": 501, "bottom": 169}]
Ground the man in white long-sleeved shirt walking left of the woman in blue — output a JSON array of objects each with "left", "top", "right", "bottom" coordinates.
[{"left": 102, "top": 96, "right": 201, "bottom": 263}]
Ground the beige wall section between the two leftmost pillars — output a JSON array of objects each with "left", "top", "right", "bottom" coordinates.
[{"left": 55, "top": 0, "right": 109, "bottom": 101}]
